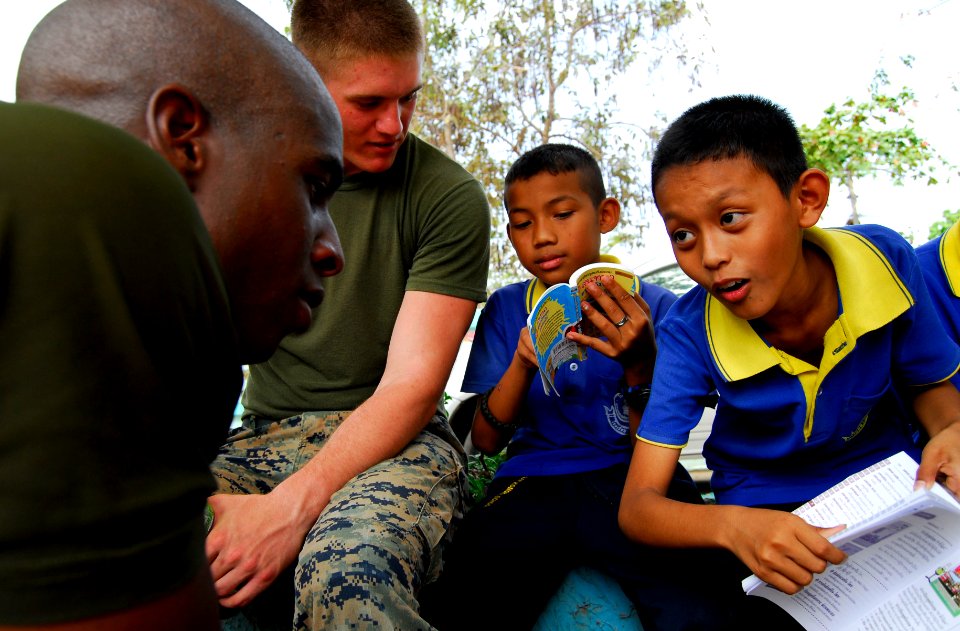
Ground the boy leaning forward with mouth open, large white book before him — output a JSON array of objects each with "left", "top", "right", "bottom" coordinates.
[{"left": 620, "top": 96, "right": 960, "bottom": 598}]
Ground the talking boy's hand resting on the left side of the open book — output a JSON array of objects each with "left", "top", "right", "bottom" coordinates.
[{"left": 730, "top": 508, "right": 847, "bottom": 594}]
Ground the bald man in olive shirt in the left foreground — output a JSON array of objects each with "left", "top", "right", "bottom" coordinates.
[{"left": 0, "top": 0, "right": 343, "bottom": 630}]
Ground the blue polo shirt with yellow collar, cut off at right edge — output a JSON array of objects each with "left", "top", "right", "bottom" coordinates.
[{"left": 917, "top": 224, "right": 960, "bottom": 388}]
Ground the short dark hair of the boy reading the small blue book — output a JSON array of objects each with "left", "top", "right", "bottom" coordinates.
[{"left": 503, "top": 143, "right": 607, "bottom": 211}]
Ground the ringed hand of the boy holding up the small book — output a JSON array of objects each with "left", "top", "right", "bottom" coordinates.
[{"left": 567, "top": 276, "right": 657, "bottom": 383}]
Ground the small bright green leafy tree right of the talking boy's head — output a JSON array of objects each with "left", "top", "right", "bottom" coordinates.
[{"left": 800, "top": 69, "right": 949, "bottom": 223}]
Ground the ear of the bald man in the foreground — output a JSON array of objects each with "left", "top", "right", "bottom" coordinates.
[{"left": 146, "top": 83, "right": 210, "bottom": 191}]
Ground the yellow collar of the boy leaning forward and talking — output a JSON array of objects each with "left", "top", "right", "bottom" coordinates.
[{"left": 704, "top": 227, "right": 914, "bottom": 381}]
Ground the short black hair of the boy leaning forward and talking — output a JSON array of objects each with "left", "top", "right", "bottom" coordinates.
[{"left": 650, "top": 95, "right": 807, "bottom": 201}]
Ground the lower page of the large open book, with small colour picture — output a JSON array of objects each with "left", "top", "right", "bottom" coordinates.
[{"left": 751, "top": 490, "right": 960, "bottom": 631}]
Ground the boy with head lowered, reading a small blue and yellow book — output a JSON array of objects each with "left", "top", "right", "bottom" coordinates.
[{"left": 420, "top": 144, "right": 752, "bottom": 630}]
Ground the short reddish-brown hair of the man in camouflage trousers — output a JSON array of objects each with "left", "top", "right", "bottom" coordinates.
[{"left": 290, "top": 0, "right": 425, "bottom": 74}]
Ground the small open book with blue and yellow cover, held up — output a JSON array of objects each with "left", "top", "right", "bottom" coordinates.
[{"left": 527, "top": 263, "right": 640, "bottom": 394}]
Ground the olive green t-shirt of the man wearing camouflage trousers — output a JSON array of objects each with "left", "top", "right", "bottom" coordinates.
[{"left": 243, "top": 134, "right": 490, "bottom": 419}]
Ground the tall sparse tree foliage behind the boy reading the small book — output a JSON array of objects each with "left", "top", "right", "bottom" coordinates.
[{"left": 414, "top": 0, "right": 689, "bottom": 289}]
